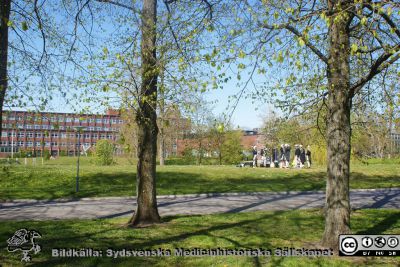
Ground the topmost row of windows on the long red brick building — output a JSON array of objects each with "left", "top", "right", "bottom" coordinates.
[{"left": 3, "top": 115, "right": 123, "bottom": 124}]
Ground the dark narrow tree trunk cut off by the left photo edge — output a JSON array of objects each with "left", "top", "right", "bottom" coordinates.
[{"left": 0, "top": 0, "right": 11, "bottom": 134}]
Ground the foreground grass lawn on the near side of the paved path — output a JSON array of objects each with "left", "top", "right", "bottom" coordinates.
[{"left": 0, "top": 209, "right": 400, "bottom": 267}]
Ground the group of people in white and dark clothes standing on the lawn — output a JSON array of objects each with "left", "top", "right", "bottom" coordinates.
[{"left": 253, "top": 144, "right": 311, "bottom": 168}]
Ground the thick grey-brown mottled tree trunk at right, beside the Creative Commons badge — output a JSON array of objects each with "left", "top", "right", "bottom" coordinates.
[{"left": 322, "top": 0, "right": 352, "bottom": 249}]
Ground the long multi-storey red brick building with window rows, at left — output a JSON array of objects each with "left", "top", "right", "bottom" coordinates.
[{"left": 0, "top": 110, "right": 123, "bottom": 157}]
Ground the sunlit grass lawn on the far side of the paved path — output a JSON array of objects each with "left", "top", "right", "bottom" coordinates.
[{"left": 0, "top": 157, "right": 400, "bottom": 200}]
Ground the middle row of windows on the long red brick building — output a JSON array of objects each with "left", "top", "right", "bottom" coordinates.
[{"left": 1, "top": 132, "right": 119, "bottom": 140}]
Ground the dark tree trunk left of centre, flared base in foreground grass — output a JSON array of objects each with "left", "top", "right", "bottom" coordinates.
[{"left": 128, "top": 0, "right": 160, "bottom": 226}]
